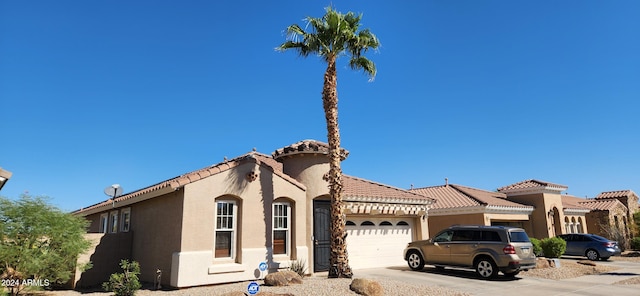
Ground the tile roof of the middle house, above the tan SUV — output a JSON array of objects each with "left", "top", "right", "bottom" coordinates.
[{"left": 410, "top": 184, "right": 532, "bottom": 209}]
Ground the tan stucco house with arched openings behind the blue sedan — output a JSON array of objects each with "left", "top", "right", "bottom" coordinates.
[{"left": 498, "top": 179, "right": 589, "bottom": 239}]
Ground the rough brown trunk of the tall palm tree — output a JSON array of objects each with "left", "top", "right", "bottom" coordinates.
[{"left": 322, "top": 57, "right": 353, "bottom": 278}]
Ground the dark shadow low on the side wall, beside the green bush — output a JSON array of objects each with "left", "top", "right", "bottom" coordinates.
[{"left": 76, "top": 231, "right": 133, "bottom": 288}]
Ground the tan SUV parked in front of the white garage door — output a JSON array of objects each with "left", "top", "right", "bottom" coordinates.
[{"left": 404, "top": 226, "right": 536, "bottom": 279}]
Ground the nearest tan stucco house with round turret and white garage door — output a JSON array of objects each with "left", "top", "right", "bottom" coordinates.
[{"left": 74, "top": 140, "right": 433, "bottom": 287}]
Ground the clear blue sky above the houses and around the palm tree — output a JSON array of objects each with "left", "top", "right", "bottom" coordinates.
[{"left": 0, "top": 0, "right": 640, "bottom": 210}]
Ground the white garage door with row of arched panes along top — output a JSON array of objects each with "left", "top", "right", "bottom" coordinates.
[{"left": 347, "top": 218, "right": 413, "bottom": 269}]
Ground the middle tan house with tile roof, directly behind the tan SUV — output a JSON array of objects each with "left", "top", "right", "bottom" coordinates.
[{"left": 410, "top": 182, "right": 535, "bottom": 234}]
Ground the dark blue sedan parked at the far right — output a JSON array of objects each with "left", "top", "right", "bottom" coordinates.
[{"left": 558, "top": 233, "right": 621, "bottom": 261}]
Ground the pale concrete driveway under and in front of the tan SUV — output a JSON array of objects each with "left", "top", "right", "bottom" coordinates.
[{"left": 354, "top": 261, "right": 640, "bottom": 296}]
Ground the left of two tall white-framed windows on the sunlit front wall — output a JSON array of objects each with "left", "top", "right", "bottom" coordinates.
[{"left": 214, "top": 200, "right": 237, "bottom": 258}]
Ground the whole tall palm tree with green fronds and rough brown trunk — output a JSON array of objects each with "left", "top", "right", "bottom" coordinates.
[{"left": 277, "top": 7, "right": 380, "bottom": 278}]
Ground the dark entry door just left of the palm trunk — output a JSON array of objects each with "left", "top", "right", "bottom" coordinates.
[{"left": 313, "top": 200, "right": 331, "bottom": 272}]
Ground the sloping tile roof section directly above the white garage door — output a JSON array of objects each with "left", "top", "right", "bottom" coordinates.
[{"left": 342, "top": 175, "right": 433, "bottom": 202}]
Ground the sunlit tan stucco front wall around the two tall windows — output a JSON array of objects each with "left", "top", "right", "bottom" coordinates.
[{"left": 172, "top": 163, "right": 310, "bottom": 287}]
